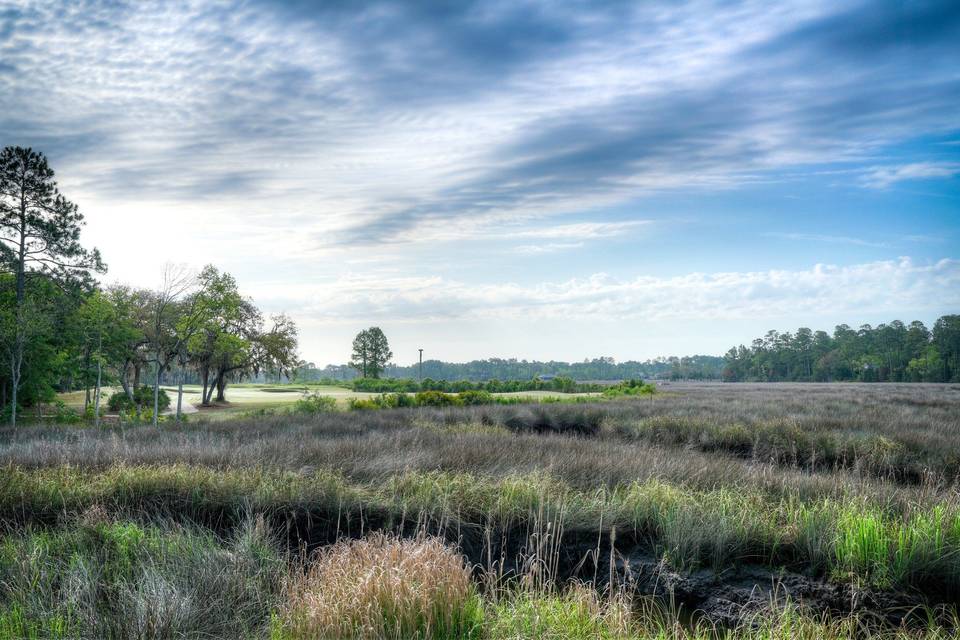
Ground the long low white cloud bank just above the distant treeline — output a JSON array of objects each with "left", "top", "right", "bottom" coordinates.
[{"left": 255, "top": 258, "right": 960, "bottom": 324}]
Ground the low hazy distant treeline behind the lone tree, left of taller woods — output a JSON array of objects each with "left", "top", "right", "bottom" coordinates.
[{"left": 295, "top": 356, "right": 725, "bottom": 382}]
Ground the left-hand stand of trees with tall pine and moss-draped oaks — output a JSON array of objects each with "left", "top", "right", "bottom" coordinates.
[{"left": 0, "top": 147, "right": 300, "bottom": 425}]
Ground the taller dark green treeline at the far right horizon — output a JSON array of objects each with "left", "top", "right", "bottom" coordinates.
[{"left": 723, "top": 315, "right": 960, "bottom": 382}]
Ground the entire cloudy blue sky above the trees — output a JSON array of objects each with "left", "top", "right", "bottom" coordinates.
[{"left": 0, "top": 0, "right": 960, "bottom": 364}]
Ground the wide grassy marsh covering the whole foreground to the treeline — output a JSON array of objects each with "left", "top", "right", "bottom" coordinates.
[{"left": 0, "top": 384, "right": 960, "bottom": 638}]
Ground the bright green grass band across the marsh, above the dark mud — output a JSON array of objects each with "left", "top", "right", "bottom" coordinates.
[{"left": 0, "top": 465, "right": 960, "bottom": 594}]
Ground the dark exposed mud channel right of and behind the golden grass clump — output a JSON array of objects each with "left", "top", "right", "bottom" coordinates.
[{"left": 278, "top": 512, "right": 936, "bottom": 627}]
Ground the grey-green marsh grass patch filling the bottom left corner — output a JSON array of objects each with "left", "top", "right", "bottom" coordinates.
[{"left": 0, "top": 520, "right": 285, "bottom": 638}]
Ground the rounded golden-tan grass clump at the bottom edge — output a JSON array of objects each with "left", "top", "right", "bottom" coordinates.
[{"left": 274, "top": 533, "right": 483, "bottom": 640}]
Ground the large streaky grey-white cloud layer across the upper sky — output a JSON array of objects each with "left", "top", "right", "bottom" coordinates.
[{"left": 0, "top": 0, "right": 960, "bottom": 248}]
